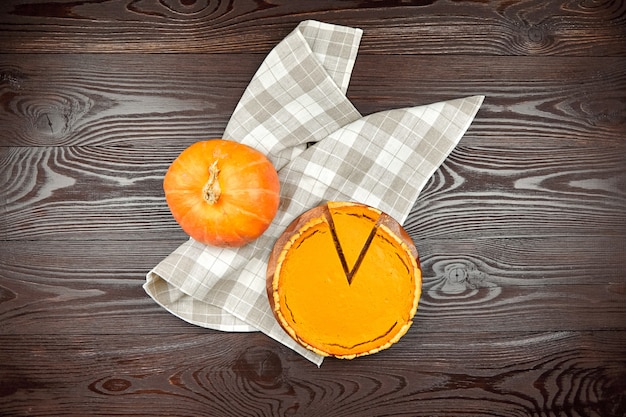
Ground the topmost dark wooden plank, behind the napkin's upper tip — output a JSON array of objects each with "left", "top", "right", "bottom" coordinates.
[{"left": 0, "top": 0, "right": 626, "bottom": 56}]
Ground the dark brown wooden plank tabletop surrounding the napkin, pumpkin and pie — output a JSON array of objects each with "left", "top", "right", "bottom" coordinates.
[{"left": 0, "top": 0, "right": 626, "bottom": 417}]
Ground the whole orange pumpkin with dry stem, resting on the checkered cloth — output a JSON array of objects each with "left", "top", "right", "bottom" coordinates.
[{"left": 163, "top": 139, "right": 280, "bottom": 247}]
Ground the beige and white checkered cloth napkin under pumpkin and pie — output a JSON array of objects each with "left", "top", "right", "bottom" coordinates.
[{"left": 144, "top": 21, "right": 484, "bottom": 365}]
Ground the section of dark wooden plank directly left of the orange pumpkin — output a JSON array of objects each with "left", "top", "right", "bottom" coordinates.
[{"left": 0, "top": 147, "right": 184, "bottom": 240}]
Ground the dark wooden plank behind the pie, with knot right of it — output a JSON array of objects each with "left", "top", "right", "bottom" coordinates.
[{"left": 0, "top": 236, "right": 626, "bottom": 335}]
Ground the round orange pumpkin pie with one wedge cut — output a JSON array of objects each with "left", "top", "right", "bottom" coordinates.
[{"left": 267, "top": 202, "right": 422, "bottom": 359}]
